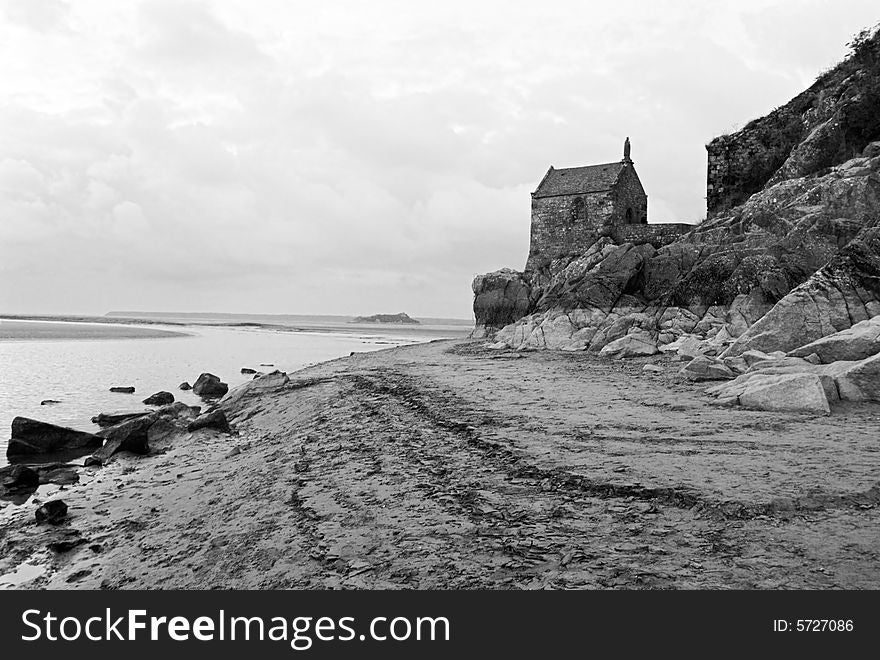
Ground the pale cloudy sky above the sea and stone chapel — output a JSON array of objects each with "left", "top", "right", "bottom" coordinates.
[{"left": 0, "top": 0, "right": 880, "bottom": 318}]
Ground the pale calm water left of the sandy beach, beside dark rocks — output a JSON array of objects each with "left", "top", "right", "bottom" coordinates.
[{"left": 0, "top": 320, "right": 467, "bottom": 464}]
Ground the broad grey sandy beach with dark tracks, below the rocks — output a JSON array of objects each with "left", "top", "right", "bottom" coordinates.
[{"left": 0, "top": 341, "right": 880, "bottom": 589}]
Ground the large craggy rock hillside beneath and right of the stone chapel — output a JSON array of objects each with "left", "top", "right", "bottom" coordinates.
[{"left": 473, "top": 25, "right": 880, "bottom": 374}]
